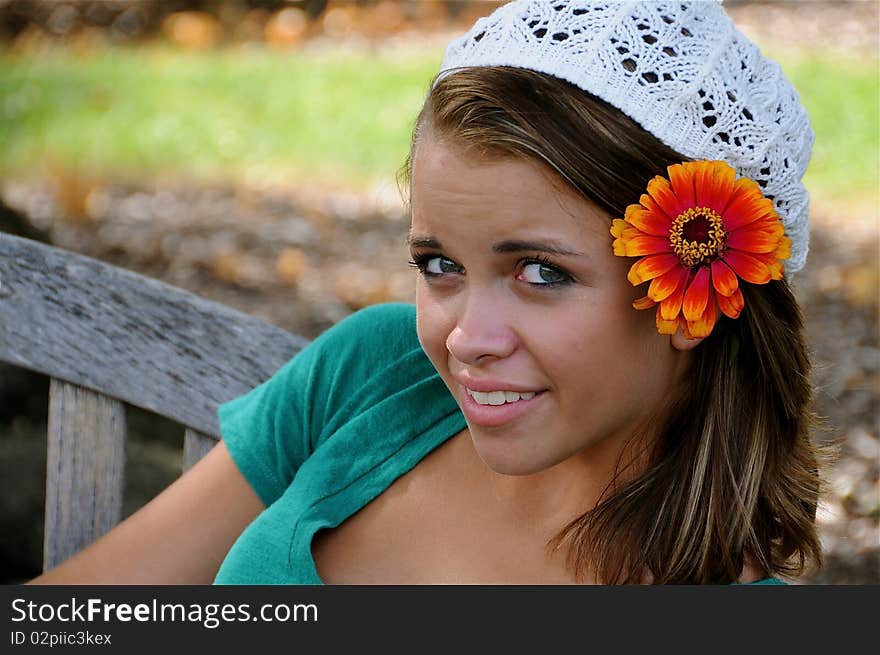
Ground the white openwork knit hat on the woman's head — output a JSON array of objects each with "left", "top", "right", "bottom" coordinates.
[{"left": 438, "top": 0, "right": 815, "bottom": 274}]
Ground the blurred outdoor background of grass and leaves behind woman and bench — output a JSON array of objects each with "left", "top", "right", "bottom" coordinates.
[{"left": 0, "top": 0, "right": 880, "bottom": 584}]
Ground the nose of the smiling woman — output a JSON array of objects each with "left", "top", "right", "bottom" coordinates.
[{"left": 446, "top": 299, "right": 517, "bottom": 365}]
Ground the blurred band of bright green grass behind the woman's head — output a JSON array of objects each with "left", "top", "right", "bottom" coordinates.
[{"left": 0, "top": 47, "right": 880, "bottom": 205}]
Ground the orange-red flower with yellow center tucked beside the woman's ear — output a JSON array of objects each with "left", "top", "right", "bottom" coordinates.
[{"left": 611, "top": 161, "right": 791, "bottom": 338}]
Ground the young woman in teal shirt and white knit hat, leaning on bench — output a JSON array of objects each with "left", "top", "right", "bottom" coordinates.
[{"left": 35, "top": 0, "right": 821, "bottom": 584}]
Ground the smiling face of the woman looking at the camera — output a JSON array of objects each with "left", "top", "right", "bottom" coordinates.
[{"left": 410, "top": 136, "right": 684, "bottom": 475}]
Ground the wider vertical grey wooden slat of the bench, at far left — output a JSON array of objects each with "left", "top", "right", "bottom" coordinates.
[{"left": 43, "top": 379, "right": 126, "bottom": 571}]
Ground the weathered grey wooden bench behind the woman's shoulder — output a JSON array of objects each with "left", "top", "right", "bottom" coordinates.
[{"left": 0, "top": 233, "right": 308, "bottom": 570}]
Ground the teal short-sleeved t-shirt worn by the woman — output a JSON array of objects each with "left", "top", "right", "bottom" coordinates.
[{"left": 214, "top": 303, "right": 780, "bottom": 584}]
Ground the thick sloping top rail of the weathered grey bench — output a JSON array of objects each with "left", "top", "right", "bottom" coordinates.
[{"left": 0, "top": 233, "right": 308, "bottom": 438}]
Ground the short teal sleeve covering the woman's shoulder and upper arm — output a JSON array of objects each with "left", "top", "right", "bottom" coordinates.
[{"left": 217, "top": 303, "right": 420, "bottom": 506}]
